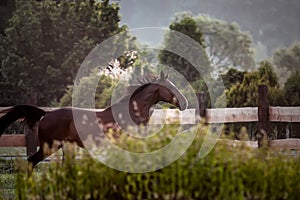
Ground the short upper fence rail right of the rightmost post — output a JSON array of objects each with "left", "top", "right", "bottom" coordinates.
[{"left": 269, "top": 107, "right": 300, "bottom": 122}]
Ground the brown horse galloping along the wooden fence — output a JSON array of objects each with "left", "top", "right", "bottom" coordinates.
[{"left": 0, "top": 72, "right": 187, "bottom": 166}]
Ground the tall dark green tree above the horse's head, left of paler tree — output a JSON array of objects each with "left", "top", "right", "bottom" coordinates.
[{"left": 159, "top": 14, "right": 211, "bottom": 82}]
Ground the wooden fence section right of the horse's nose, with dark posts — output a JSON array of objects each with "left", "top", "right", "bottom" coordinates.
[{"left": 198, "top": 85, "right": 300, "bottom": 150}]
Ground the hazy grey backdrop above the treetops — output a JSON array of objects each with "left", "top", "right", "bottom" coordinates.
[{"left": 119, "top": 0, "right": 300, "bottom": 55}]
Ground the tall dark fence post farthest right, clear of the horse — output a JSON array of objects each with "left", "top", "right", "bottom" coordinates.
[{"left": 257, "top": 85, "right": 269, "bottom": 147}]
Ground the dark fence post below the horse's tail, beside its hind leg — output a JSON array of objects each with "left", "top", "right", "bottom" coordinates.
[{"left": 26, "top": 125, "right": 38, "bottom": 156}]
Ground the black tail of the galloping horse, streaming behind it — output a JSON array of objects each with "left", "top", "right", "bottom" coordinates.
[{"left": 0, "top": 105, "right": 46, "bottom": 136}]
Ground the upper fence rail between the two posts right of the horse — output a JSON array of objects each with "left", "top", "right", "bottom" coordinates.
[{"left": 206, "top": 107, "right": 258, "bottom": 123}]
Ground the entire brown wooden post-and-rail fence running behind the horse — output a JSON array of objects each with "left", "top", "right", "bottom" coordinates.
[{"left": 0, "top": 85, "right": 300, "bottom": 155}]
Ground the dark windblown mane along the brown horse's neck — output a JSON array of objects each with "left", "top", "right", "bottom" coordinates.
[{"left": 118, "top": 74, "right": 160, "bottom": 103}]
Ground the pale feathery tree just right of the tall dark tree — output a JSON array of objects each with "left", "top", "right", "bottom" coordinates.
[{"left": 195, "top": 15, "right": 255, "bottom": 72}]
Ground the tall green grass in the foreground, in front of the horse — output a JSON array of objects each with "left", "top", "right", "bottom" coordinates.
[{"left": 11, "top": 127, "right": 300, "bottom": 199}]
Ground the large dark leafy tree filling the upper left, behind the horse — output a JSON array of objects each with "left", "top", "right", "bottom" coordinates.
[{"left": 0, "top": 0, "right": 125, "bottom": 106}]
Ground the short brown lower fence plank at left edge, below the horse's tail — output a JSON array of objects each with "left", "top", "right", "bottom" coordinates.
[{"left": 0, "top": 134, "right": 26, "bottom": 147}]
